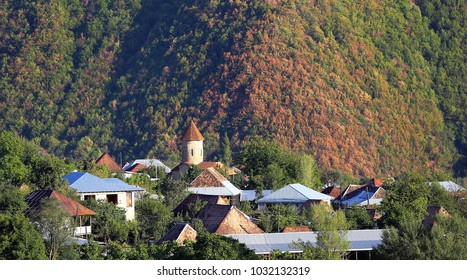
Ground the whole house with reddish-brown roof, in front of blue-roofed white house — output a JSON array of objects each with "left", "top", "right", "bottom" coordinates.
[{"left": 26, "top": 190, "right": 96, "bottom": 237}]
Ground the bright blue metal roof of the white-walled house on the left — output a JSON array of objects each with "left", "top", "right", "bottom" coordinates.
[{"left": 63, "top": 172, "right": 144, "bottom": 193}]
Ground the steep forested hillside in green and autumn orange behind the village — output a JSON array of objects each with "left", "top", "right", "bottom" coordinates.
[{"left": 0, "top": 0, "right": 467, "bottom": 177}]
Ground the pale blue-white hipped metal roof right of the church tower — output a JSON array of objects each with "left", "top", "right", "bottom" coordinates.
[{"left": 256, "top": 184, "right": 333, "bottom": 203}]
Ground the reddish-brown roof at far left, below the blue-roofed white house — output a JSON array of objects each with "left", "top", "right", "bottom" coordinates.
[{"left": 26, "top": 190, "right": 96, "bottom": 217}]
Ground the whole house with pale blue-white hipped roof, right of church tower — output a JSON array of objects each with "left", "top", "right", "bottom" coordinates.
[{"left": 256, "top": 184, "right": 333, "bottom": 210}]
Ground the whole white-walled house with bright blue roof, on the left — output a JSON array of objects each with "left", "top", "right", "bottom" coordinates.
[{"left": 64, "top": 171, "right": 144, "bottom": 220}]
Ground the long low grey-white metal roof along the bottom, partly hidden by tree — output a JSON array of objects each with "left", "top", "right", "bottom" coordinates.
[{"left": 225, "top": 229, "right": 383, "bottom": 254}]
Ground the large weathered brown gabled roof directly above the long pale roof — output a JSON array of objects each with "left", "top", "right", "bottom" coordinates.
[{"left": 195, "top": 204, "right": 264, "bottom": 234}]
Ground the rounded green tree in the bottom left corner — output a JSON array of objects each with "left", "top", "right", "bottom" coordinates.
[{"left": 0, "top": 213, "right": 47, "bottom": 260}]
